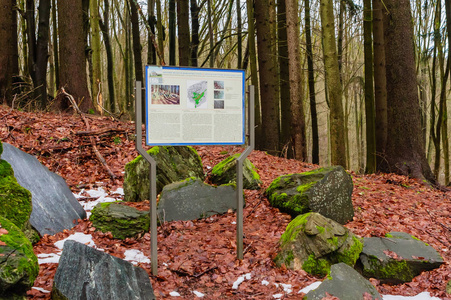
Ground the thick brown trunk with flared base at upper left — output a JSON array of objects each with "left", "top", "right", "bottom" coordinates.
[{"left": 58, "top": 0, "right": 93, "bottom": 112}]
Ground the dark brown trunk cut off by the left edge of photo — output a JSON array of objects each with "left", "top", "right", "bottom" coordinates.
[{"left": 0, "top": 0, "right": 19, "bottom": 106}]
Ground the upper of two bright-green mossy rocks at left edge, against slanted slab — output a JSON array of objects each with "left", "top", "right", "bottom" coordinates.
[{"left": 0, "top": 159, "right": 32, "bottom": 234}]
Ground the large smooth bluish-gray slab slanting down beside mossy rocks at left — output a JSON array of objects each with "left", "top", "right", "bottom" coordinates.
[{"left": 2, "top": 143, "right": 86, "bottom": 235}]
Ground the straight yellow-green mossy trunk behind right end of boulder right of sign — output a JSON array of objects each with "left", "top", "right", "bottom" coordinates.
[{"left": 320, "top": 0, "right": 347, "bottom": 168}]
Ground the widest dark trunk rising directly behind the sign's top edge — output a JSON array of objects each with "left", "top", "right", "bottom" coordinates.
[{"left": 177, "top": 0, "right": 191, "bottom": 66}]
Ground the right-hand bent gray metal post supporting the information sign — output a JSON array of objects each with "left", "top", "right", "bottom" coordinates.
[{"left": 236, "top": 85, "right": 255, "bottom": 259}]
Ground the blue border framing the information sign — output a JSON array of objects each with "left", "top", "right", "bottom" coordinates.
[{"left": 145, "top": 66, "right": 246, "bottom": 146}]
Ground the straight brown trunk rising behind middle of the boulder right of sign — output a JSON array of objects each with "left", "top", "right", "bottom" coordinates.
[{"left": 286, "top": 0, "right": 307, "bottom": 161}]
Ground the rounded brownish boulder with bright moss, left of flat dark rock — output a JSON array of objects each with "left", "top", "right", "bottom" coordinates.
[{"left": 275, "top": 213, "right": 363, "bottom": 276}]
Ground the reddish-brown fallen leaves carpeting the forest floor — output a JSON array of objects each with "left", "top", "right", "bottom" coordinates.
[{"left": 0, "top": 106, "right": 451, "bottom": 299}]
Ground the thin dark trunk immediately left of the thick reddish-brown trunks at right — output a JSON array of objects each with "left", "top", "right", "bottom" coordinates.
[{"left": 363, "top": 0, "right": 376, "bottom": 173}]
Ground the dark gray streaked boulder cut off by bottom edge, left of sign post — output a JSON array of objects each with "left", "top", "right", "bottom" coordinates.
[{"left": 52, "top": 241, "right": 155, "bottom": 300}]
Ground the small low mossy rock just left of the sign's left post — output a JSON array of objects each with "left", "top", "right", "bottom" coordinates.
[{"left": 89, "top": 202, "right": 150, "bottom": 239}]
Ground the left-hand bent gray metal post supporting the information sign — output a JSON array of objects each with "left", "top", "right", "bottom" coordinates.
[{"left": 135, "top": 81, "right": 158, "bottom": 276}]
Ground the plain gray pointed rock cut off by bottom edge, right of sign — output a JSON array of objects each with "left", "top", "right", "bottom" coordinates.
[{"left": 304, "top": 263, "right": 382, "bottom": 300}]
